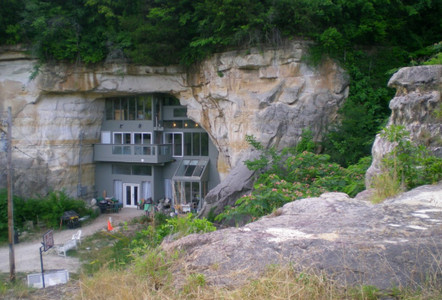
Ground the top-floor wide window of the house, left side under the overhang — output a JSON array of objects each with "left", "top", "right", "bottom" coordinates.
[{"left": 106, "top": 95, "right": 153, "bottom": 120}]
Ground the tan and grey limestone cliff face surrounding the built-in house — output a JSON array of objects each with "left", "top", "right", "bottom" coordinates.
[{"left": 0, "top": 42, "right": 348, "bottom": 195}]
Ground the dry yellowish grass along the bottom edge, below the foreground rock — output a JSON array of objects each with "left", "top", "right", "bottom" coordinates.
[{"left": 76, "top": 266, "right": 442, "bottom": 300}]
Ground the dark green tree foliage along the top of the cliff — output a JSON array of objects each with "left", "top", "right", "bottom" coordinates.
[{"left": 0, "top": 0, "right": 441, "bottom": 65}]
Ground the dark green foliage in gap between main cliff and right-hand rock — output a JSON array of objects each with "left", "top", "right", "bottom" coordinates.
[{"left": 323, "top": 49, "right": 406, "bottom": 167}]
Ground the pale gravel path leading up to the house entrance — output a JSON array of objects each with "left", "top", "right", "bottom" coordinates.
[{"left": 0, "top": 208, "right": 143, "bottom": 273}]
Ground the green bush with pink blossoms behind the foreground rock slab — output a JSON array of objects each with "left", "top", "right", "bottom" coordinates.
[{"left": 216, "top": 132, "right": 371, "bottom": 222}]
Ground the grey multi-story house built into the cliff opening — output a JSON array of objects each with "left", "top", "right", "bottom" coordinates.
[{"left": 94, "top": 94, "right": 220, "bottom": 212}]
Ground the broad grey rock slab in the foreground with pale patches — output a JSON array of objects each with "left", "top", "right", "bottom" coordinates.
[{"left": 163, "top": 183, "right": 442, "bottom": 289}]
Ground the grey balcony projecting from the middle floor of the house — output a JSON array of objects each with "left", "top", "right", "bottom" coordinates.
[{"left": 94, "top": 144, "right": 173, "bottom": 164}]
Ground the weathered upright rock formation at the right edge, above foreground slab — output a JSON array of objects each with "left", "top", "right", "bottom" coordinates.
[{"left": 366, "top": 65, "right": 442, "bottom": 188}]
